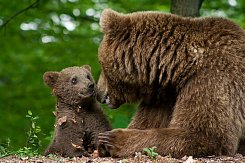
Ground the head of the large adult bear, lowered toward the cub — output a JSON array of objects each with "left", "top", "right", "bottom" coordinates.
[{"left": 97, "top": 9, "right": 155, "bottom": 108}]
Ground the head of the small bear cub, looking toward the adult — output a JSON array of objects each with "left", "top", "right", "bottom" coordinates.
[{"left": 43, "top": 65, "right": 97, "bottom": 106}]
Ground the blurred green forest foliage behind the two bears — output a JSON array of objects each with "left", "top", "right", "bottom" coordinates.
[{"left": 0, "top": 0, "right": 245, "bottom": 153}]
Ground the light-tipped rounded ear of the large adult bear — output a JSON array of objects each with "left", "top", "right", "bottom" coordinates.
[{"left": 100, "top": 9, "right": 130, "bottom": 36}]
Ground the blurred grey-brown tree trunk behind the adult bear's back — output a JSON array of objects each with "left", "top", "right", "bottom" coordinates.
[{"left": 170, "top": 0, "right": 204, "bottom": 17}]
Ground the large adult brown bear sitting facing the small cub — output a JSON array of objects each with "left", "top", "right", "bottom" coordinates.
[{"left": 98, "top": 9, "right": 245, "bottom": 157}]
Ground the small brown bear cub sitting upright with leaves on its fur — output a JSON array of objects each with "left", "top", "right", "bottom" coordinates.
[{"left": 44, "top": 65, "right": 111, "bottom": 157}]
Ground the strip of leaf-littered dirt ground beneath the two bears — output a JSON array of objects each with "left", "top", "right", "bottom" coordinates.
[{"left": 0, "top": 153, "right": 245, "bottom": 163}]
